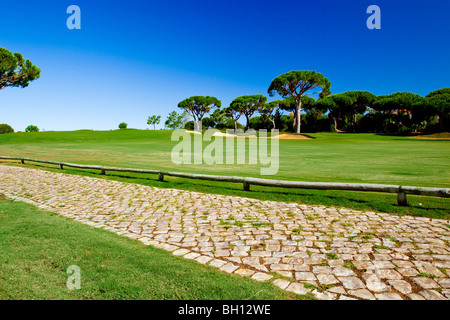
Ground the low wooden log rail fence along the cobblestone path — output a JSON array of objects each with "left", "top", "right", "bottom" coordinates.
[{"left": 0, "top": 156, "right": 450, "bottom": 206}]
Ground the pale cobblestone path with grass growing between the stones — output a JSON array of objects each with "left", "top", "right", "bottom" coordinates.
[{"left": 0, "top": 166, "right": 450, "bottom": 300}]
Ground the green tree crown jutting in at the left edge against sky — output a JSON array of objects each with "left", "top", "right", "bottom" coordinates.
[{"left": 0, "top": 48, "right": 41, "bottom": 90}]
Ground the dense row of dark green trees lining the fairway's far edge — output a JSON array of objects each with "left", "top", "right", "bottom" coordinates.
[{"left": 179, "top": 88, "right": 450, "bottom": 134}]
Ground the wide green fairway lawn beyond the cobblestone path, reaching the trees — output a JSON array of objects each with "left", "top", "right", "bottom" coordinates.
[{"left": 0, "top": 130, "right": 450, "bottom": 218}]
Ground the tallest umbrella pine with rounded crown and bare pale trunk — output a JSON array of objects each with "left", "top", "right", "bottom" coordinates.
[{"left": 267, "top": 70, "right": 331, "bottom": 133}]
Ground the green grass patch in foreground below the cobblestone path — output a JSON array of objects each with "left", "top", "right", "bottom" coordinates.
[{"left": 0, "top": 201, "right": 308, "bottom": 300}]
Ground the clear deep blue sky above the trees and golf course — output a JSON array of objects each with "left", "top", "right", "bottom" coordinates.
[{"left": 0, "top": 0, "right": 450, "bottom": 131}]
